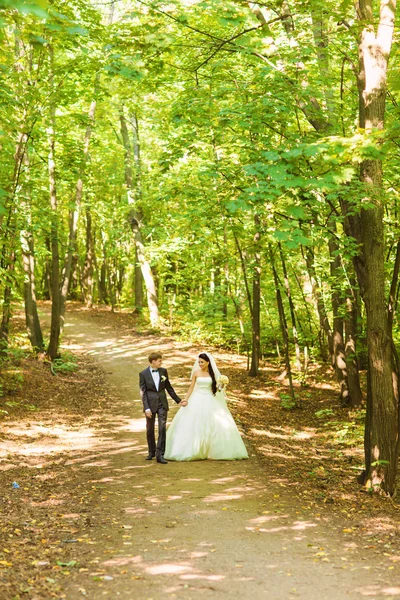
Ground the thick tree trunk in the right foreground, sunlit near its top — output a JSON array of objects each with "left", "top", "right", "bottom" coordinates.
[{"left": 349, "top": 0, "right": 399, "bottom": 494}]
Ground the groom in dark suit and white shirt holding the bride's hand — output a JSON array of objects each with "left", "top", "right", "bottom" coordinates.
[{"left": 139, "top": 352, "right": 187, "bottom": 465}]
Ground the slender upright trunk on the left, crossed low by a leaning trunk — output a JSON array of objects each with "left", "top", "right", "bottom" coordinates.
[{"left": 47, "top": 46, "right": 61, "bottom": 360}]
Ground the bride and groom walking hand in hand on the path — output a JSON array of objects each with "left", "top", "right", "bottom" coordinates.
[{"left": 139, "top": 352, "right": 248, "bottom": 464}]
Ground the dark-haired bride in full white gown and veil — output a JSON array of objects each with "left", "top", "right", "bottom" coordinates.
[{"left": 164, "top": 352, "right": 248, "bottom": 461}]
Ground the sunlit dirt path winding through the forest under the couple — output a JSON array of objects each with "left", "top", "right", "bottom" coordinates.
[{"left": 58, "top": 310, "right": 400, "bottom": 600}]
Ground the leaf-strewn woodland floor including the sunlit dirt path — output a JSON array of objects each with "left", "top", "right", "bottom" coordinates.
[{"left": 0, "top": 306, "right": 400, "bottom": 600}]
